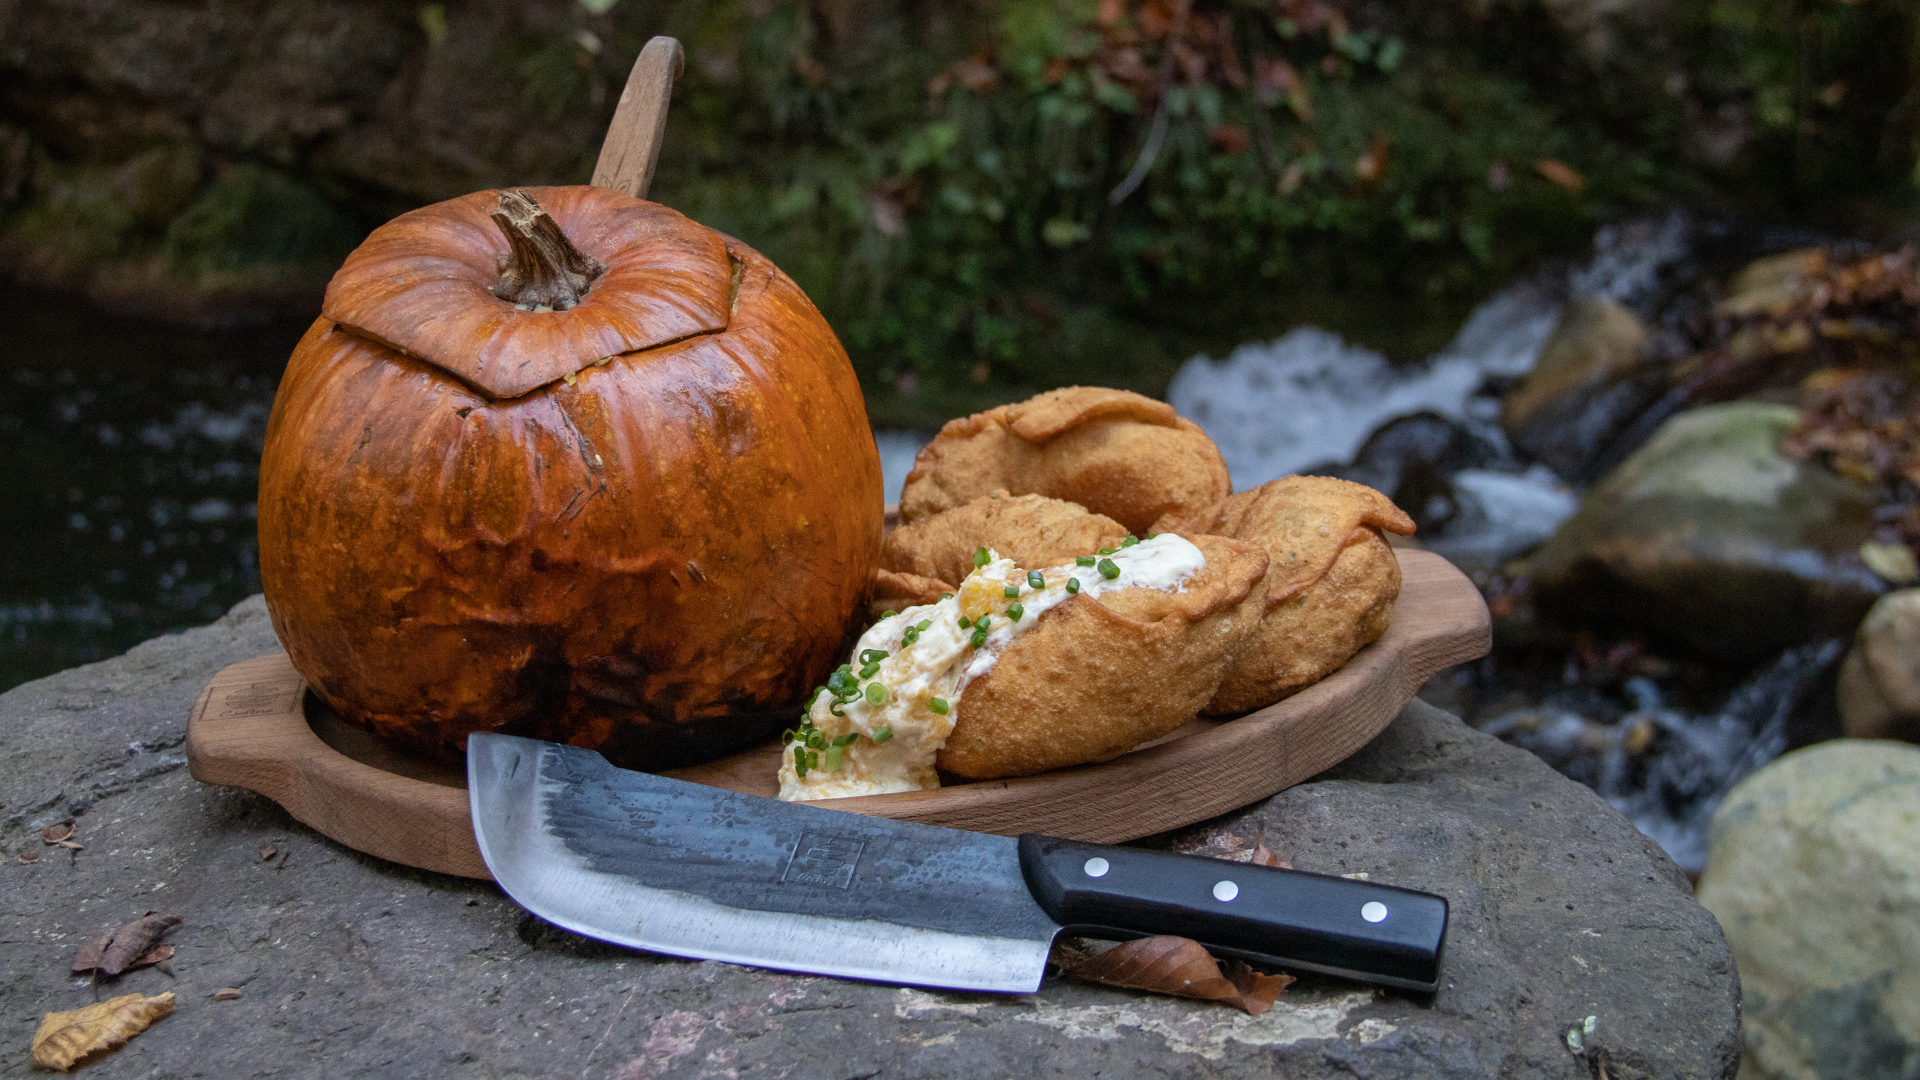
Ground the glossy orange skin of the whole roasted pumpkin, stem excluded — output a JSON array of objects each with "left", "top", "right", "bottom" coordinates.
[{"left": 259, "top": 188, "right": 883, "bottom": 769}]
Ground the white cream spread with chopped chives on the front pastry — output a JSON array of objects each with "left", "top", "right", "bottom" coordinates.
[{"left": 780, "top": 532, "right": 1206, "bottom": 801}]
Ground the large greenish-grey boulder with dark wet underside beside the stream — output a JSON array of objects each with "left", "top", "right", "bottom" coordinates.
[{"left": 1528, "top": 402, "right": 1885, "bottom": 663}]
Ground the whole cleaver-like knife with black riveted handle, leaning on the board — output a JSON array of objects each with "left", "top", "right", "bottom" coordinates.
[{"left": 467, "top": 734, "right": 1448, "bottom": 994}]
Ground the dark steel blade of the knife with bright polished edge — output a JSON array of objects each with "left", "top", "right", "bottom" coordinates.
[{"left": 467, "top": 734, "right": 1058, "bottom": 992}]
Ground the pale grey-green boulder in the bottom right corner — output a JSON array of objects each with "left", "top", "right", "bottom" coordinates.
[{"left": 1699, "top": 740, "right": 1920, "bottom": 1080}]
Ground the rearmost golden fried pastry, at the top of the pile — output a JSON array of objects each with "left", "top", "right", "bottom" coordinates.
[{"left": 900, "top": 386, "right": 1233, "bottom": 536}]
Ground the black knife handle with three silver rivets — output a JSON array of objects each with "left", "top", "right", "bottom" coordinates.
[{"left": 1020, "top": 832, "right": 1446, "bottom": 992}]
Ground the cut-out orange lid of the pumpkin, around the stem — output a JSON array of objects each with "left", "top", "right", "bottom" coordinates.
[{"left": 321, "top": 186, "right": 733, "bottom": 398}]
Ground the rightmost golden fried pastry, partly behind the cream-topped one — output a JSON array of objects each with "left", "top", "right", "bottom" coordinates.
[{"left": 1154, "top": 477, "right": 1413, "bottom": 715}]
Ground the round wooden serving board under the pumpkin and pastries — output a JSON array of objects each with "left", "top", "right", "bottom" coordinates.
[{"left": 186, "top": 550, "right": 1490, "bottom": 878}]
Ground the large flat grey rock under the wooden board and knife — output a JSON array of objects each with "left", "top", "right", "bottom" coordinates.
[{"left": 0, "top": 598, "right": 1740, "bottom": 1080}]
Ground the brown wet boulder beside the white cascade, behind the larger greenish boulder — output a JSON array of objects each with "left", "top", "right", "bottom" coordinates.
[{"left": 1500, "top": 296, "right": 1663, "bottom": 480}]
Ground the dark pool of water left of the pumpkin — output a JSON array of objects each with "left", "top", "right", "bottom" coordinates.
[{"left": 0, "top": 290, "right": 305, "bottom": 690}]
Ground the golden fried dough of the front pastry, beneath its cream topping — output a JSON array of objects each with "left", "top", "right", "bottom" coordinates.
[{"left": 937, "top": 536, "right": 1267, "bottom": 780}]
